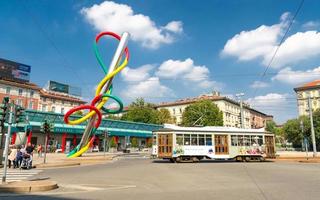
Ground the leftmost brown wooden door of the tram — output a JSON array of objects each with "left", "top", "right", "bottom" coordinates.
[{"left": 158, "top": 134, "right": 172, "bottom": 158}]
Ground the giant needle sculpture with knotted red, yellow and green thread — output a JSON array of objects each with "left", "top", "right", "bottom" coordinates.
[{"left": 64, "top": 32, "right": 129, "bottom": 158}]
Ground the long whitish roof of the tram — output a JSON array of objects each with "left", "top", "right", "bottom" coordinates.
[{"left": 153, "top": 124, "right": 267, "bottom": 133}]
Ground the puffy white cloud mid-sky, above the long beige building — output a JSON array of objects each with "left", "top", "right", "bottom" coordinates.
[{"left": 156, "top": 58, "right": 223, "bottom": 89}]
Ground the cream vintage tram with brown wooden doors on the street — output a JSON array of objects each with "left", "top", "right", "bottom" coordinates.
[{"left": 152, "top": 125, "right": 275, "bottom": 162}]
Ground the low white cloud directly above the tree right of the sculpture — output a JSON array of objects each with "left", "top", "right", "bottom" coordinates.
[{"left": 122, "top": 77, "right": 173, "bottom": 99}]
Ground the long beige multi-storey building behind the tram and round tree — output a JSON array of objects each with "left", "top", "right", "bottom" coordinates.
[{"left": 156, "top": 93, "right": 272, "bottom": 128}]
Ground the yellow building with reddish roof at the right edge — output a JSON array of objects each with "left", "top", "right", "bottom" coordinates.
[{"left": 294, "top": 80, "right": 320, "bottom": 116}]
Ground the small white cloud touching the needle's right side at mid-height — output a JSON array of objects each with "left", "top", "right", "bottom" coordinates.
[{"left": 121, "top": 64, "right": 155, "bottom": 82}]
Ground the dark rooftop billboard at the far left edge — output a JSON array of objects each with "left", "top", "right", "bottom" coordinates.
[{"left": 0, "top": 58, "right": 31, "bottom": 82}]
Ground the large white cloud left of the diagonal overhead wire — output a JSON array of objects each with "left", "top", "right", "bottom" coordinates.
[{"left": 221, "top": 13, "right": 289, "bottom": 61}]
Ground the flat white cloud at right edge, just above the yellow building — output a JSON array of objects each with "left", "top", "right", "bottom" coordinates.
[{"left": 272, "top": 66, "right": 320, "bottom": 85}]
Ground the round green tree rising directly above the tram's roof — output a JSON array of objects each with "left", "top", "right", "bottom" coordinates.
[{"left": 182, "top": 100, "right": 223, "bottom": 126}]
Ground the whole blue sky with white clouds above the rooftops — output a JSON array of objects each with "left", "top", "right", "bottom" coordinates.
[{"left": 0, "top": 0, "right": 320, "bottom": 123}]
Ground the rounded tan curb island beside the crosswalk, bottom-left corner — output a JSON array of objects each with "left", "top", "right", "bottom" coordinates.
[{"left": 0, "top": 180, "right": 58, "bottom": 193}]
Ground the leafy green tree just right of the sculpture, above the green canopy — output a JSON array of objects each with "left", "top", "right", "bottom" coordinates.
[{"left": 121, "top": 98, "right": 158, "bottom": 124}]
